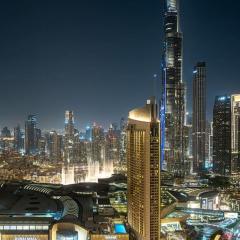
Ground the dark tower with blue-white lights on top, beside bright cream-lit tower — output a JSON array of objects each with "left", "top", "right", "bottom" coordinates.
[{"left": 213, "top": 95, "right": 231, "bottom": 175}]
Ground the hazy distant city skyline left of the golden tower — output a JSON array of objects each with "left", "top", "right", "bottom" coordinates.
[{"left": 0, "top": 111, "right": 126, "bottom": 181}]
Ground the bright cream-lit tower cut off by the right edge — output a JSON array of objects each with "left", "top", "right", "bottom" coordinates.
[{"left": 231, "top": 94, "right": 240, "bottom": 173}]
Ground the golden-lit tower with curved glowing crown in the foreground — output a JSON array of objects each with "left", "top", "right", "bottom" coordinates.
[{"left": 127, "top": 98, "right": 160, "bottom": 240}]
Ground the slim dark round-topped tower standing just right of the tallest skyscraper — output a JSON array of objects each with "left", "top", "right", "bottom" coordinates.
[{"left": 192, "top": 62, "right": 206, "bottom": 173}]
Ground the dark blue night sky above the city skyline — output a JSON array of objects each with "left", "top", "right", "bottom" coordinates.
[{"left": 0, "top": 0, "right": 240, "bottom": 129}]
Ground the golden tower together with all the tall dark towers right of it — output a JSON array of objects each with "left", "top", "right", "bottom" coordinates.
[{"left": 127, "top": 0, "right": 240, "bottom": 240}]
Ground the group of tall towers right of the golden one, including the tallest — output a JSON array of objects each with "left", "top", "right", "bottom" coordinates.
[{"left": 160, "top": 0, "right": 240, "bottom": 177}]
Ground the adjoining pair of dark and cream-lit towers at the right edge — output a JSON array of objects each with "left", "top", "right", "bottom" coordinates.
[{"left": 213, "top": 94, "right": 240, "bottom": 175}]
